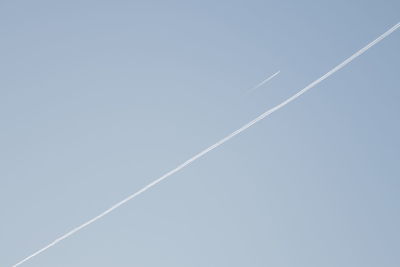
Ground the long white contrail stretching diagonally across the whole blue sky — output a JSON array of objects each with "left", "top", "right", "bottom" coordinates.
[{"left": 13, "top": 23, "right": 400, "bottom": 267}]
